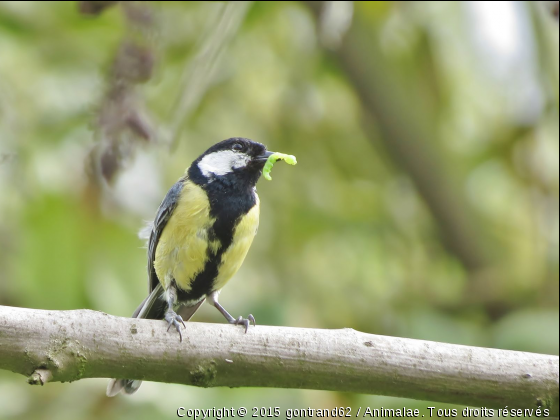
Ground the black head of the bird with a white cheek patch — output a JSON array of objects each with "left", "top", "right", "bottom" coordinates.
[{"left": 188, "top": 137, "right": 272, "bottom": 189}]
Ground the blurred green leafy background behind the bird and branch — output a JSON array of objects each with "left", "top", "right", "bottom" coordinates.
[{"left": 0, "top": 1, "right": 559, "bottom": 420}]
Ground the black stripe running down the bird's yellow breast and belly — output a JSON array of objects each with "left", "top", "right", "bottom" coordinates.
[{"left": 177, "top": 181, "right": 256, "bottom": 302}]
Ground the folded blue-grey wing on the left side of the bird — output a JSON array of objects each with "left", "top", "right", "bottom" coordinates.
[{"left": 148, "top": 178, "right": 185, "bottom": 293}]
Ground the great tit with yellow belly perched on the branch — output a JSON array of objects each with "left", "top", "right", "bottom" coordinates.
[{"left": 107, "top": 137, "right": 273, "bottom": 396}]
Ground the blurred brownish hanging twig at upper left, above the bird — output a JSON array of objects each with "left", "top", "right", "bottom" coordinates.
[{"left": 85, "top": 1, "right": 156, "bottom": 185}]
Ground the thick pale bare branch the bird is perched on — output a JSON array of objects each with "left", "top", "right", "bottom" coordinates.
[{"left": 0, "top": 306, "right": 559, "bottom": 416}]
